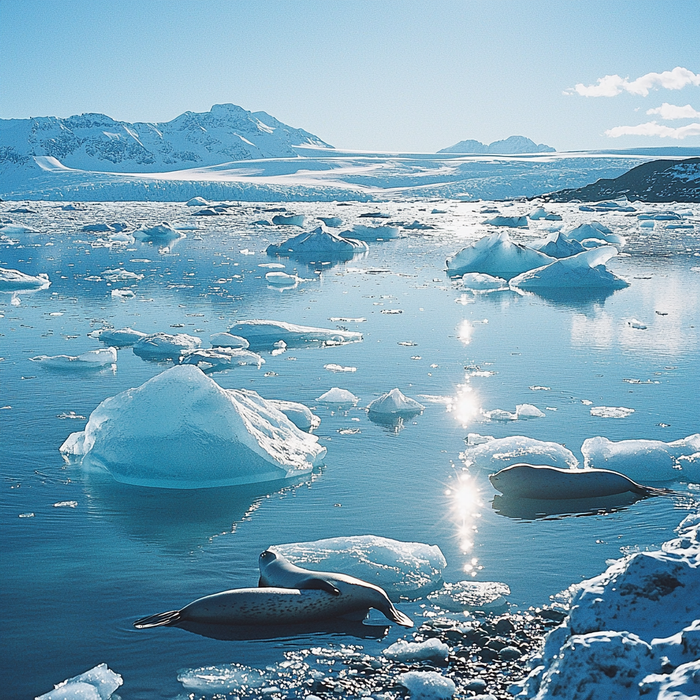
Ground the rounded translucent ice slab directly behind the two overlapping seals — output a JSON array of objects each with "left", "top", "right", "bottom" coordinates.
[{"left": 270, "top": 535, "right": 447, "bottom": 601}]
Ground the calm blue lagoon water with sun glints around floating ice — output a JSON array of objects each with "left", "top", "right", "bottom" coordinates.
[{"left": 0, "top": 201, "right": 700, "bottom": 699}]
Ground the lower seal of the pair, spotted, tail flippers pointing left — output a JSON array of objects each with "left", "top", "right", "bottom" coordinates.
[{"left": 133, "top": 586, "right": 413, "bottom": 629}]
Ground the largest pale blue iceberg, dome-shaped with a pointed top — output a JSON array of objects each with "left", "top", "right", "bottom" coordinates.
[{"left": 61, "top": 365, "right": 326, "bottom": 489}]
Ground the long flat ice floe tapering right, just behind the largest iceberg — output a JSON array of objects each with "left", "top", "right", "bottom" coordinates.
[{"left": 229, "top": 319, "right": 362, "bottom": 350}]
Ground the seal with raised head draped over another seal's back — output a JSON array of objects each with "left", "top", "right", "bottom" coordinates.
[{"left": 258, "top": 549, "right": 413, "bottom": 627}]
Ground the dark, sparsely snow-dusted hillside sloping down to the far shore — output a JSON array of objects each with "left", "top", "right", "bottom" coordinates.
[{"left": 541, "top": 158, "right": 700, "bottom": 202}]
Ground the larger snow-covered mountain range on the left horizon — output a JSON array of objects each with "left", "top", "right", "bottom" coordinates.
[{"left": 0, "top": 104, "right": 331, "bottom": 176}]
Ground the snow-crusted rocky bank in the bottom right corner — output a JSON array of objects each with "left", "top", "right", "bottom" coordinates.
[{"left": 510, "top": 514, "right": 700, "bottom": 700}]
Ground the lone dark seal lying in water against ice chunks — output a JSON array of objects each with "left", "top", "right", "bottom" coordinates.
[{"left": 489, "top": 464, "right": 670, "bottom": 501}]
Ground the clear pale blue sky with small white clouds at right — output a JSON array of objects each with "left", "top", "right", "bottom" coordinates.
[{"left": 0, "top": 0, "right": 700, "bottom": 153}]
